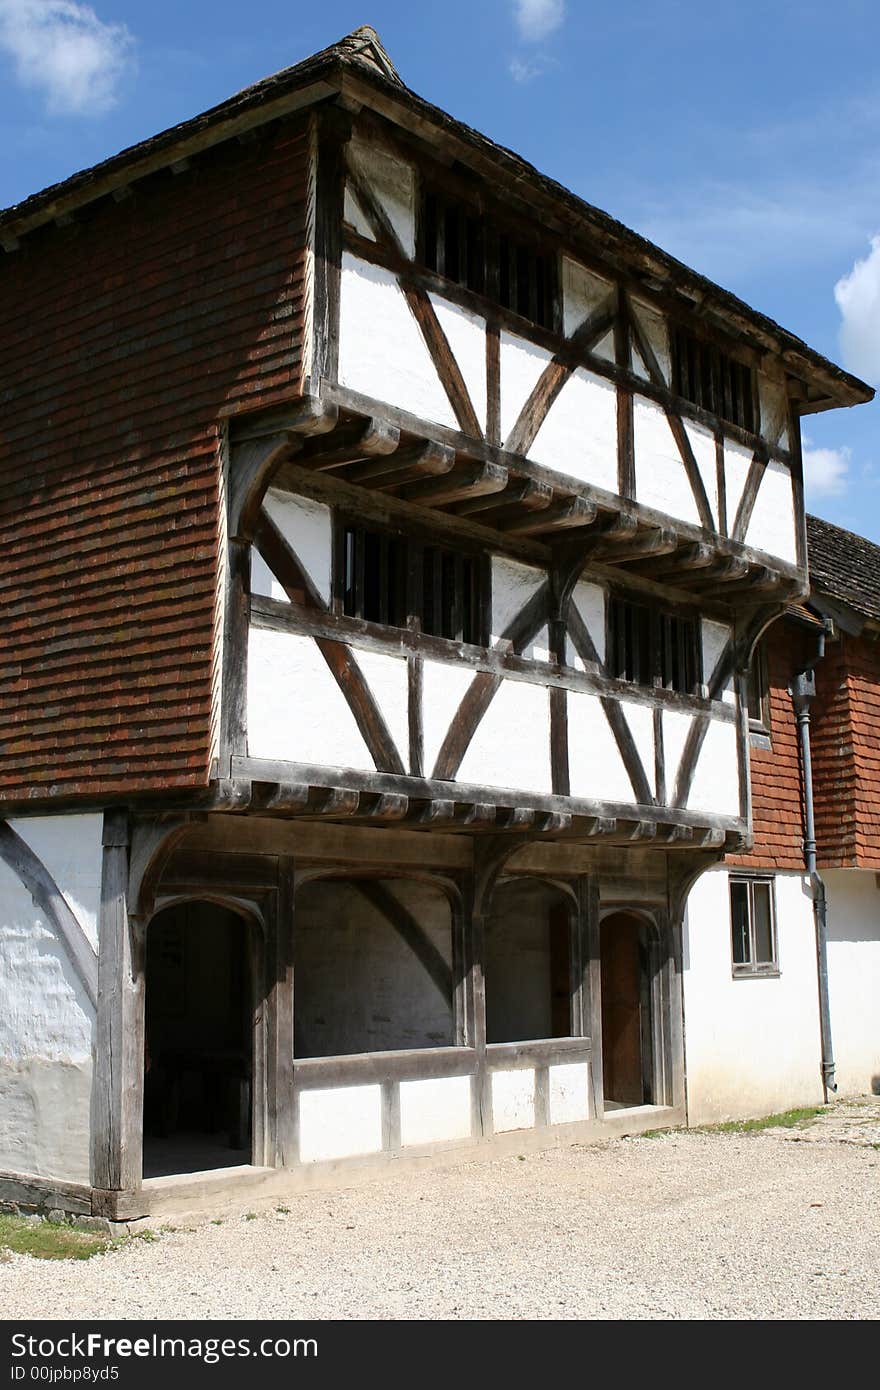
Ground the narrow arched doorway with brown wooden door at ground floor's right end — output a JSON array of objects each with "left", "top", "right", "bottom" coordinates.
[{"left": 601, "top": 912, "right": 655, "bottom": 1109}]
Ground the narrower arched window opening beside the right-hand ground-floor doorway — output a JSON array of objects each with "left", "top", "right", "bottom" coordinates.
[{"left": 484, "top": 878, "right": 580, "bottom": 1043}]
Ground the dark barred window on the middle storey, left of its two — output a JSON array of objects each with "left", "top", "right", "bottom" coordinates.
[{"left": 331, "top": 509, "right": 492, "bottom": 651}]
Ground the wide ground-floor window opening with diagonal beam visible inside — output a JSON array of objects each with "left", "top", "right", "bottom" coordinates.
[{"left": 293, "top": 877, "right": 460, "bottom": 1059}]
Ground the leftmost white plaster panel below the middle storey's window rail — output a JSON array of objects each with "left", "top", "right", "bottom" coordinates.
[{"left": 247, "top": 627, "right": 375, "bottom": 771}]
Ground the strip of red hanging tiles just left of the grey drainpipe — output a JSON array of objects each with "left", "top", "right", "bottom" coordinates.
[{"left": 726, "top": 620, "right": 816, "bottom": 870}]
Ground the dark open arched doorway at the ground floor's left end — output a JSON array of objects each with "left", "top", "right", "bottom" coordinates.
[{"left": 143, "top": 902, "right": 256, "bottom": 1177}]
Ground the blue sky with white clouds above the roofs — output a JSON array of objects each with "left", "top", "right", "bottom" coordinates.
[{"left": 0, "top": 0, "right": 880, "bottom": 542}]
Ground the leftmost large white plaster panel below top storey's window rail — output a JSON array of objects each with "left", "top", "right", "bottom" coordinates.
[{"left": 339, "top": 252, "right": 459, "bottom": 430}]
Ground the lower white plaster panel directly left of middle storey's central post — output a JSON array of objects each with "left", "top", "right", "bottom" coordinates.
[{"left": 456, "top": 680, "right": 553, "bottom": 795}]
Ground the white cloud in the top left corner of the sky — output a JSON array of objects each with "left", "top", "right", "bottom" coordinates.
[{"left": 0, "top": 0, "right": 133, "bottom": 114}]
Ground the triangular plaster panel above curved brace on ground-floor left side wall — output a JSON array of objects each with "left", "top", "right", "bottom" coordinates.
[{"left": 10, "top": 815, "right": 104, "bottom": 949}]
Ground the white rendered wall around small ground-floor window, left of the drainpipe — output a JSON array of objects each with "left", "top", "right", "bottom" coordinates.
[{"left": 683, "top": 869, "right": 822, "bottom": 1125}]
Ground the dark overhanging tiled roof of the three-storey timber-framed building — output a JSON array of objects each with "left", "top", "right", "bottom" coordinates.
[{"left": 0, "top": 25, "right": 873, "bottom": 413}]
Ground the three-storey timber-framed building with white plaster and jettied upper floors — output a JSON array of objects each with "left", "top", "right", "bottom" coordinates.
[{"left": 0, "top": 21, "right": 872, "bottom": 1219}]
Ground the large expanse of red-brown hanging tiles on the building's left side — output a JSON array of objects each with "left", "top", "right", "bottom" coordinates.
[{"left": 0, "top": 118, "right": 307, "bottom": 805}]
